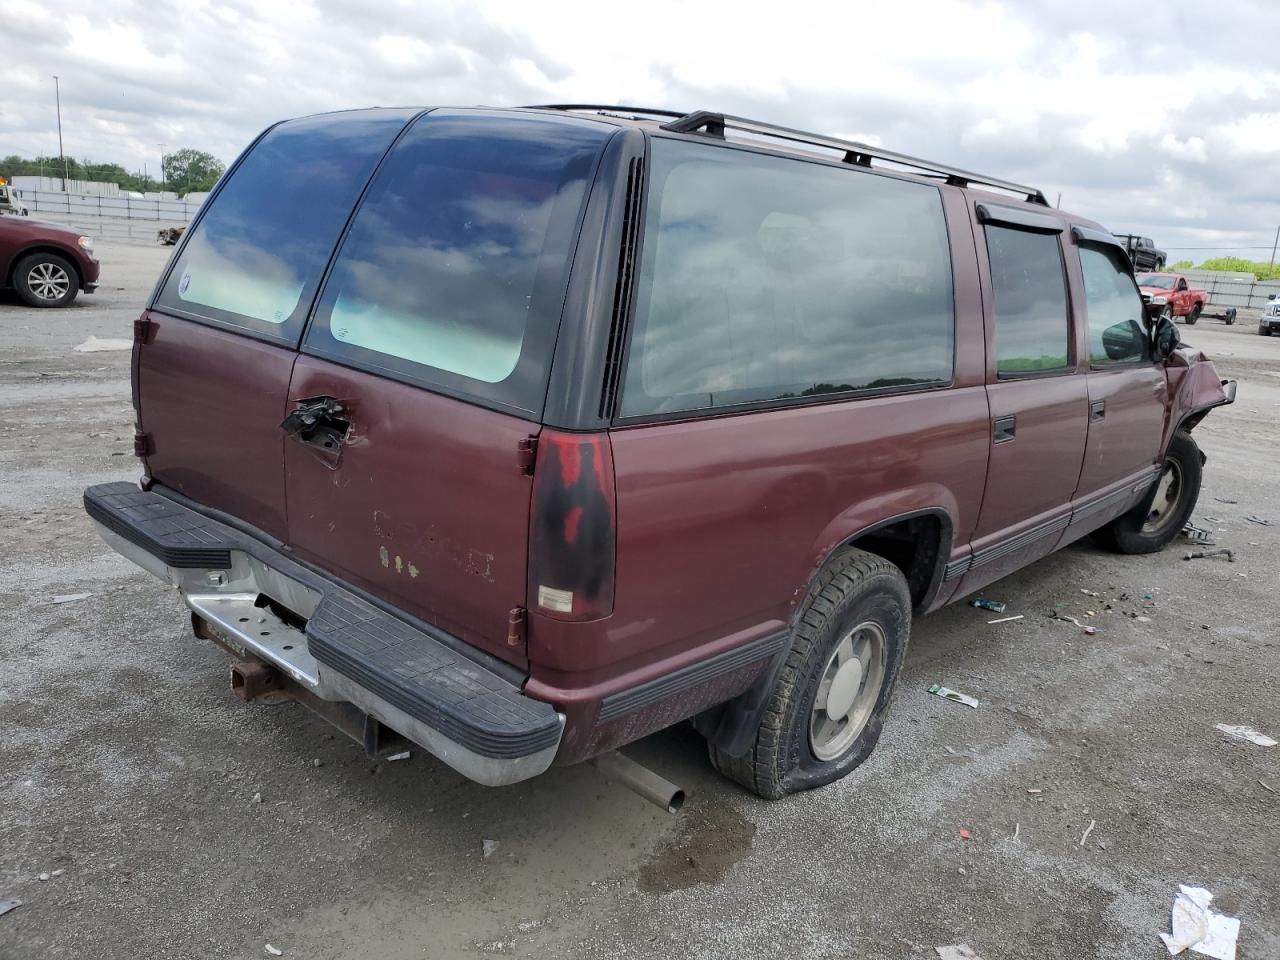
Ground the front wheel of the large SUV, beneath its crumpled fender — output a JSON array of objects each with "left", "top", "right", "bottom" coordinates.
[{"left": 1093, "top": 430, "right": 1204, "bottom": 553}]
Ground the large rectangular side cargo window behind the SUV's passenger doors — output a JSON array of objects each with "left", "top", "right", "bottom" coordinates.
[{"left": 621, "top": 138, "right": 955, "bottom": 416}]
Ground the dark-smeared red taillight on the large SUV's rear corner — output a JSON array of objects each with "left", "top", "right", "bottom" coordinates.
[{"left": 529, "top": 429, "right": 617, "bottom": 621}]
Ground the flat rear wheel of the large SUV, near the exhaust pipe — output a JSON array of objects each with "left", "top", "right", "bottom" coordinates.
[{"left": 709, "top": 549, "right": 911, "bottom": 800}]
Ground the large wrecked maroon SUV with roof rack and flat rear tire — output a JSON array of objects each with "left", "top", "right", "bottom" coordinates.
[{"left": 84, "top": 108, "right": 1235, "bottom": 797}]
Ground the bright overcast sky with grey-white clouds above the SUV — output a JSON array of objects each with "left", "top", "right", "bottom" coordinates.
[{"left": 0, "top": 0, "right": 1280, "bottom": 261}]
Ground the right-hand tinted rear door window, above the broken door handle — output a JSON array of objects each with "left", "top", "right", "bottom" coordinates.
[{"left": 306, "top": 111, "right": 614, "bottom": 411}]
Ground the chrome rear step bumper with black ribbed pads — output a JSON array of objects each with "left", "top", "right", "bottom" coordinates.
[{"left": 84, "top": 483, "right": 564, "bottom": 786}]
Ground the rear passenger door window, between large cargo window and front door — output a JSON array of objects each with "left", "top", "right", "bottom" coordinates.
[{"left": 987, "top": 225, "right": 1068, "bottom": 374}]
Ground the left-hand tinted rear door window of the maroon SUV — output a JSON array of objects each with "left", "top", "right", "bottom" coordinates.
[{"left": 156, "top": 110, "right": 413, "bottom": 343}]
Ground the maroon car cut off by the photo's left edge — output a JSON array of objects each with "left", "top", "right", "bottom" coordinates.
[{"left": 0, "top": 216, "right": 99, "bottom": 307}]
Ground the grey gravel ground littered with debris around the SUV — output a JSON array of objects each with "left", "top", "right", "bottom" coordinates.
[{"left": 0, "top": 243, "right": 1280, "bottom": 960}]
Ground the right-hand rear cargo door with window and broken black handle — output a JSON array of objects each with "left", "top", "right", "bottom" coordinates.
[{"left": 284, "top": 110, "right": 613, "bottom": 667}]
